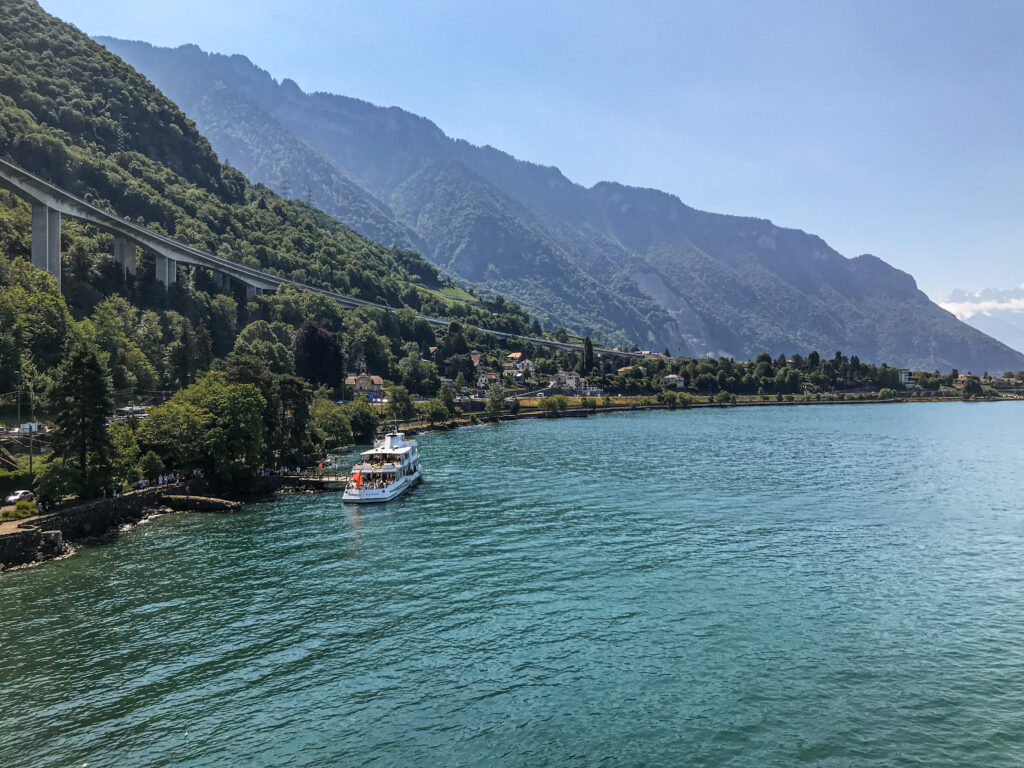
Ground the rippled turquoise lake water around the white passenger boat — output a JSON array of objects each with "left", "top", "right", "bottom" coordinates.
[{"left": 0, "top": 403, "right": 1024, "bottom": 768}]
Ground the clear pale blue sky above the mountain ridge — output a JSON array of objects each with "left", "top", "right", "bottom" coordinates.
[{"left": 42, "top": 0, "right": 1024, "bottom": 299}]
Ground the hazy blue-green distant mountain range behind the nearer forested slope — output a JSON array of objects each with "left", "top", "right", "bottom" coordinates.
[{"left": 101, "top": 38, "right": 1024, "bottom": 371}]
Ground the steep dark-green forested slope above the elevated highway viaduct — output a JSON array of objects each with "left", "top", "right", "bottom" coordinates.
[{"left": 0, "top": 0, "right": 448, "bottom": 313}]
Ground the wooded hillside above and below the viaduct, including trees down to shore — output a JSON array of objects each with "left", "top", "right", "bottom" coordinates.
[{"left": 0, "top": 0, "right": 561, "bottom": 498}]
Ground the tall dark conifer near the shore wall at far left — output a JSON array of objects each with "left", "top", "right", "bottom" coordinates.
[{"left": 49, "top": 341, "right": 114, "bottom": 492}]
